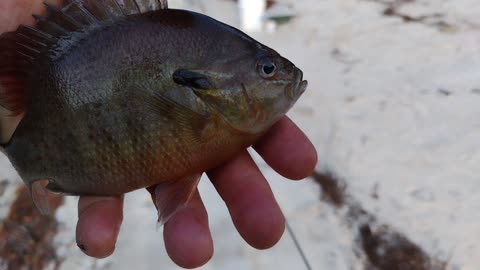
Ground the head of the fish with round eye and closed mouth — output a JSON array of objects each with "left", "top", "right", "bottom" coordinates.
[{"left": 188, "top": 46, "right": 307, "bottom": 134}]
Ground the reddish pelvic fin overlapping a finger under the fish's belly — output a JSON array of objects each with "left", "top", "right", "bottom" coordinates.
[{"left": 152, "top": 174, "right": 202, "bottom": 225}]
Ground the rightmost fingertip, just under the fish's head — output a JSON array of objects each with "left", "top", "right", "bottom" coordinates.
[{"left": 254, "top": 117, "right": 317, "bottom": 180}]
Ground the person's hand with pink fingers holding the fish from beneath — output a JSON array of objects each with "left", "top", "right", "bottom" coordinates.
[{"left": 0, "top": 0, "right": 317, "bottom": 268}]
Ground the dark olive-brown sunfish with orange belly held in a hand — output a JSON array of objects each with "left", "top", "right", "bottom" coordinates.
[{"left": 0, "top": 0, "right": 308, "bottom": 224}]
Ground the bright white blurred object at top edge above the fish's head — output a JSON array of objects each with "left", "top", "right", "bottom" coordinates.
[{"left": 238, "top": 0, "right": 267, "bottom": 32}]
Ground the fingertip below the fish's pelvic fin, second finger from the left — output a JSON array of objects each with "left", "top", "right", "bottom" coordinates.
[{"left": 163, "top": 191, "right": 213, "bottom": 268}]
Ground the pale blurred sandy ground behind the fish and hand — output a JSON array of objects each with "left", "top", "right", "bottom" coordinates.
[{"left": 0, "top": 0, "right": 480, "bottom": 270}]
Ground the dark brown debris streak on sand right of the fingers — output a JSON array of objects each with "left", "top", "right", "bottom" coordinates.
[{"left": 312, "top": 171, "right": 447, "bottom": 270}]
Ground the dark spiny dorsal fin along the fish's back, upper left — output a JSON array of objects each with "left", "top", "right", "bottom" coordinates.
[{"left": 0, "top": 0, "right": 168, "bottom": 143}]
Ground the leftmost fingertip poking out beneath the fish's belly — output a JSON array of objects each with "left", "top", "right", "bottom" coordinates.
[{"left": 76, "top": 196, "right": 123, "bottom": 258}]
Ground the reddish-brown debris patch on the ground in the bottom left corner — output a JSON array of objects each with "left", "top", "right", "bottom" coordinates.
[{"left": 0, "top": 186, "right": 63, "bottom": 270}]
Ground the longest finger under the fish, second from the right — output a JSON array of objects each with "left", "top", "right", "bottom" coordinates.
[{"left": 208, "top": 151, "right": 285, "bottom": 249}]
